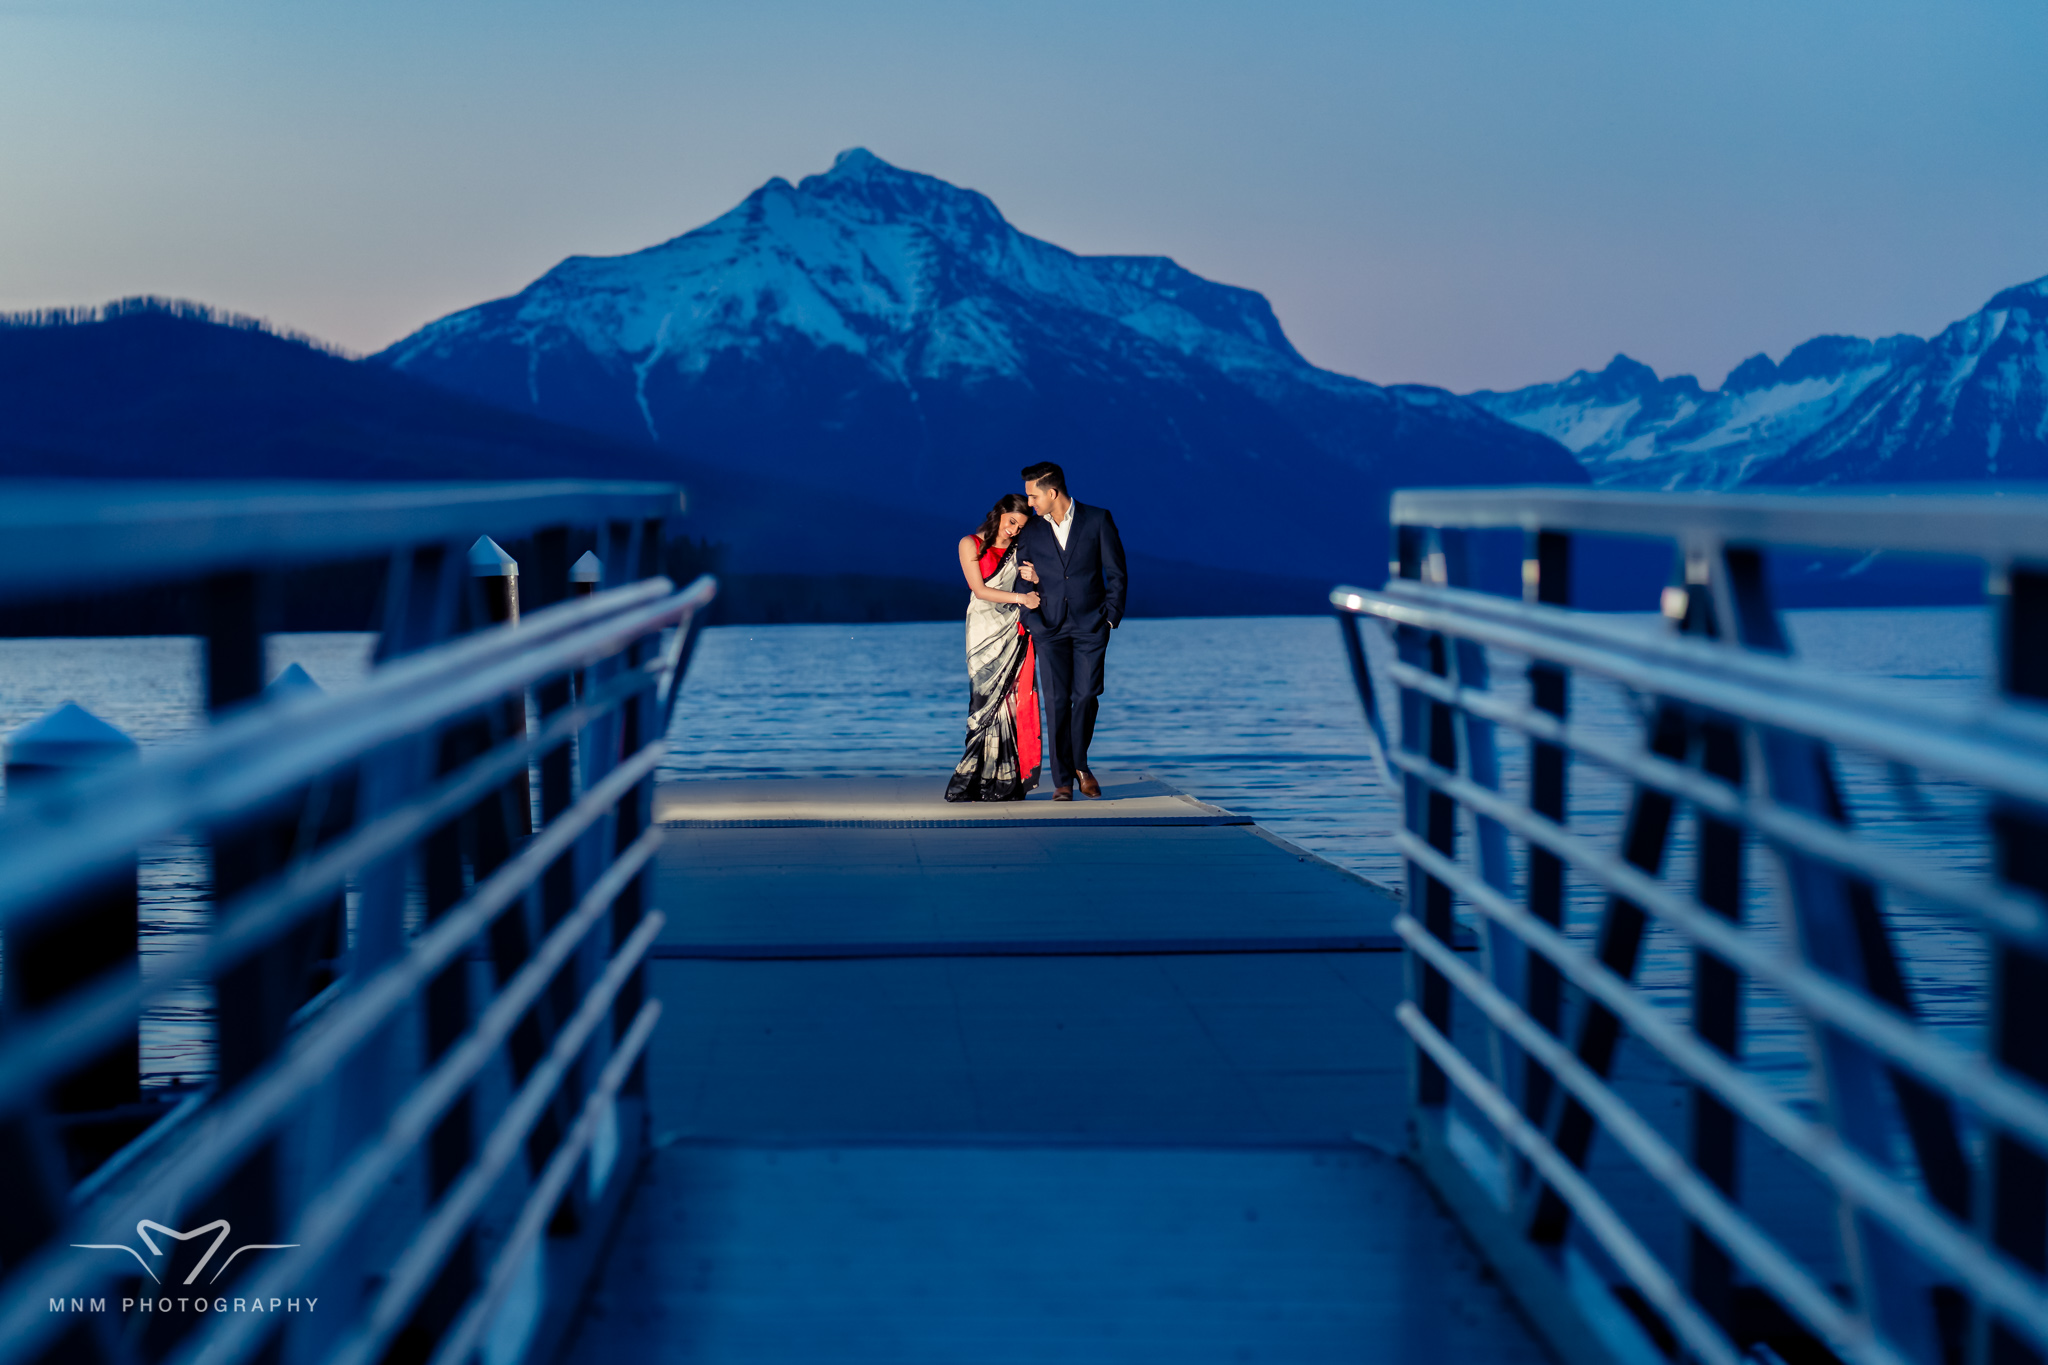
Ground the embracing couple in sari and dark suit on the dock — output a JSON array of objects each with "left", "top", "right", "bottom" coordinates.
[{"left": 946, "top": 463, "right": 1126, "bottom": 800}]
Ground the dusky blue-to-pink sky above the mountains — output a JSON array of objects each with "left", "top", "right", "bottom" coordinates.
[{"left": 0, "top": 0, "right": 2048, "bottom": 391}]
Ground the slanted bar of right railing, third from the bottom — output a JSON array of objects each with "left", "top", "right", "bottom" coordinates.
[{"left": 1401, "top": 835, "right": 2048, "bottom": 1345}]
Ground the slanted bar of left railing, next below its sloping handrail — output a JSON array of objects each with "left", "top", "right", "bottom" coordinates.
[{"left": 0, "top": 671, "right": 653, "bottom": 1107}]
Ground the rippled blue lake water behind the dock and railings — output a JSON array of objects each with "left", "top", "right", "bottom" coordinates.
[{"left": 0, "top": 608, "right": 1991, "bottom": 1093}]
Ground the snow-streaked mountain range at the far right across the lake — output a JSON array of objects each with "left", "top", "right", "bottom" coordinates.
[{"left": 1466, "top": 278, "right": 2048, "bottom": 489}]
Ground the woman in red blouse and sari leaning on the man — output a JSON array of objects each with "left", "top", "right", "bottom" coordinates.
[{"left": 946, "top": 493, "right": 1038, "bottom": 800}]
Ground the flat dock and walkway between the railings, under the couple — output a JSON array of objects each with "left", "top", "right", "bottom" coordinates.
[{"left": 565, "top": 774, "right": 1544, "bottom": 1365}]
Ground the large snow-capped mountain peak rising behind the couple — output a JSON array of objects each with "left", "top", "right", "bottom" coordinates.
[{"left": 377, "top": 149, "right": 1585, "bottom": 575}]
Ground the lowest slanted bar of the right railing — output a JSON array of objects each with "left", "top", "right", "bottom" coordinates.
[{"left": 1395, "top": 1001, "right": 1744, "bottom": 1365}]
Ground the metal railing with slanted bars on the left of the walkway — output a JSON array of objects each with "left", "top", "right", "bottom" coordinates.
[{"left": 0, "top": 485, "right": 715, "bottom": 1365}]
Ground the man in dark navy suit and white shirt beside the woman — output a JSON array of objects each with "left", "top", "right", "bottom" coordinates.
[{"left": 1018, "top": 463, "right": 1124, "bottom": 800}]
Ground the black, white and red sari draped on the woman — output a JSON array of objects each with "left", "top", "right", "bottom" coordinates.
[{"left": 946, "top": 546, "right": 1038, "bottom": 800}]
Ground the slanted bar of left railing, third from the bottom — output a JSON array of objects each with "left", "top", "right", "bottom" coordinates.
[{"left": 157, "top": 829, "right": 662, "bottom": 1361}]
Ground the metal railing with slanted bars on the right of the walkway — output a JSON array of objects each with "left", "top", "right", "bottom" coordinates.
[{"left": 1331, "top": 489, "right": 2048, "bottom": 1365}]
